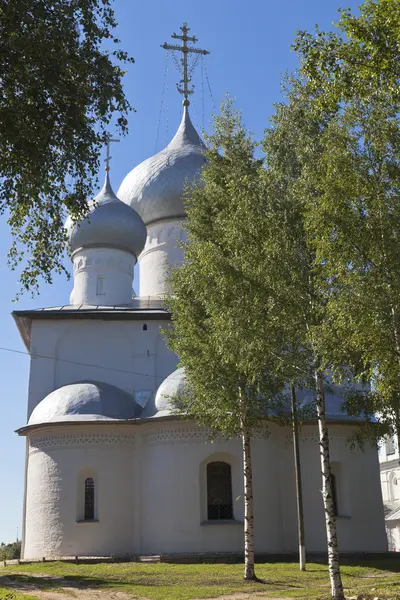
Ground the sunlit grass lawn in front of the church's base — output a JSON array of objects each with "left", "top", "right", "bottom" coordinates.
[{"left": 0, "top": 556, "right": 400, "bottom": 600}]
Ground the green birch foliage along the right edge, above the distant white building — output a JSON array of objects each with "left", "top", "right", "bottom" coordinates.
[{"left": 295, "top": 0, "right": 400, "bottom": 432}]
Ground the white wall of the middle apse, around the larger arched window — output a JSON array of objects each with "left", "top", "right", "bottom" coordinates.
[{"left": 141, "top": 422, "right": 292, "bottom": 554}]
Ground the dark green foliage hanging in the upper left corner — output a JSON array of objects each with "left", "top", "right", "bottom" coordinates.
[{"left": 0, "top": 0, "right": 133, "bottom": 291}]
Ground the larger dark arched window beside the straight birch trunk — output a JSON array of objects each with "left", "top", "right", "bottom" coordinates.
[{"left": 207, "top": 462, "right": 233, "bottom": 520}]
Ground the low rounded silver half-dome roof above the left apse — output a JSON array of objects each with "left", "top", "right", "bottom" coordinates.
[{"left": 28, "top": 381, "right": 141, "bottom": 425}]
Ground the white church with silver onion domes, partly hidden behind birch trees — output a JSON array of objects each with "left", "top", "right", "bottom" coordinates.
[{"left": 13, "top": 22, "right": 387, "bottom": 559}]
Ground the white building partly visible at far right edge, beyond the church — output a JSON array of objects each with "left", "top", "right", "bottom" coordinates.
[{"left": 379, "top": 436, "right": 400, "bottom": 552}]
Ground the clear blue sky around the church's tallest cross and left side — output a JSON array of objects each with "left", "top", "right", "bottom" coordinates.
[{"left": 0, "top": 0, "right": 358, "bottom": 542}]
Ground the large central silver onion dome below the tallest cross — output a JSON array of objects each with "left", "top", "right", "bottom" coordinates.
[{"left": 118, "top": 106, "right": 205, "bottom": 225}]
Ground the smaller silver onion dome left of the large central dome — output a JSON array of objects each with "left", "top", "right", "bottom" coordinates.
[{"left": 65, "top": 172, "right": 147, "bottom": 257}]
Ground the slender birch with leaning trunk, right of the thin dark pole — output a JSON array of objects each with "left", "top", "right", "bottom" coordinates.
[{"left": 264, "top": 77, "right": 344, "bottom": 600}]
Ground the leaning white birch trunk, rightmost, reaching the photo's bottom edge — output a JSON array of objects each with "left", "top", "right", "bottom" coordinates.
[{"left": 315, "top": 368, "right": 344, "bottom": 600}]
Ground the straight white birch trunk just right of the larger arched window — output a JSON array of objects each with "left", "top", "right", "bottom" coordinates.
[{"left": 240, "top": 394, "right": 257, "bottom": 581}]
